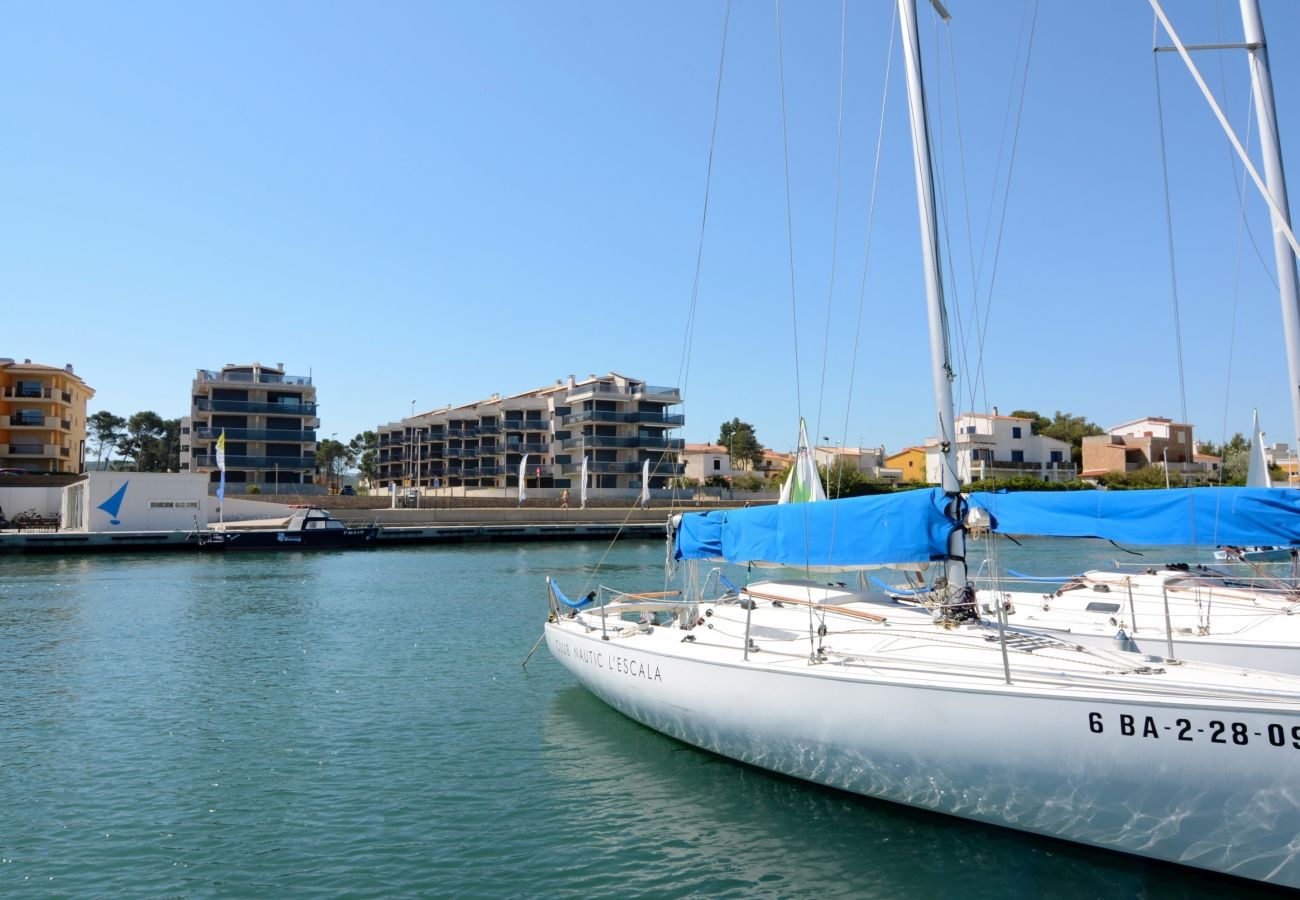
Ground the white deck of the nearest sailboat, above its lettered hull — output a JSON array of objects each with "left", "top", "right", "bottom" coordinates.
[{"left": 562, "top": 581, "right": 1300, "bottom": 706}]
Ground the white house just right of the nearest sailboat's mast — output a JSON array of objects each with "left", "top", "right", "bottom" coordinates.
[{"left": 926, "top": 412, "right": 1078, "bottom": 484}]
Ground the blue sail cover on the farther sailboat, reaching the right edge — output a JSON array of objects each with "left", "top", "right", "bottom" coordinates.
[{"left": 970, "top": 488, "right": 1300, "bottom": 546}]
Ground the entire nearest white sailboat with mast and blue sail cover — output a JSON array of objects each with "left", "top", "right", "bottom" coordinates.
[{"left": 545, "top": 0, "right": 1300, "bottom": 887}]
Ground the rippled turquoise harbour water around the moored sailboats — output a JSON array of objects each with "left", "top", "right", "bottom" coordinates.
[{"left": 0, "top": 541, "right": 1279, "bottom": 897}]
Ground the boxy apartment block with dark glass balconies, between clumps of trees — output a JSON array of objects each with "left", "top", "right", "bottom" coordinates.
[{"left": 181, "top": 363, "right": 320, "bottom": 493}]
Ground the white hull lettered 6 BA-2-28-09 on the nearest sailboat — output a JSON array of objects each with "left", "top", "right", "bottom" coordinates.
[{"left": 546, "top": 582, "right": 1300, "bottom": 887}]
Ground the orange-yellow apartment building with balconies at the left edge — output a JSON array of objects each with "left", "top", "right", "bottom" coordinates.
[{"left": 0, "top": 358, "right": 95, "bottom": 473}]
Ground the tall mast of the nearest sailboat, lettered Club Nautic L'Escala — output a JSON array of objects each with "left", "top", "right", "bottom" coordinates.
[{"left": 898, "top": 0, "right": 961, "bottom": 596}]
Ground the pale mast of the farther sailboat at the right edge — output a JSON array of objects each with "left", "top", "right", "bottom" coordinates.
[{"left": 1242, "top": 0, "right": 1300, "bottom": 457}]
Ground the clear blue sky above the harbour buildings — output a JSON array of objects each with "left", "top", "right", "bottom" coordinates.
[{"left": 0, "top": 0, "right": 1300, "bottom": 450}]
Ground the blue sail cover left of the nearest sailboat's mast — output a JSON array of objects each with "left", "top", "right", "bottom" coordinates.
[{"left": 673, "top": 488, "right": 954, "bottom": 567}]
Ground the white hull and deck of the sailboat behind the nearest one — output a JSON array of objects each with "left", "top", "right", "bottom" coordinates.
[{"left": 978, "top": 571, "right": 1300, "bottom": 676}]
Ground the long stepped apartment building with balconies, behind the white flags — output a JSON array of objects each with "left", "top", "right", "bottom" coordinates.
[{"left": 376, "top": 372, "right": 685, "bottom": 489}]
